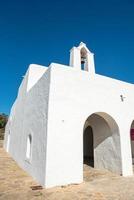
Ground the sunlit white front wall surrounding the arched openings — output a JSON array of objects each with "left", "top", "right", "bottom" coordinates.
[{"left": 46, "top": 64, "right": 134, "bottom": 187}]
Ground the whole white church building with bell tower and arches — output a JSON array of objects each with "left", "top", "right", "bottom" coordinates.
[{"left": 4, "top": 42, "right": 134, "bottom": 188}]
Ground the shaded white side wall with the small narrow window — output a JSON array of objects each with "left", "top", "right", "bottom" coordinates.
[{"left": 4, "top": 65, "right": 50, "bottom": 185}]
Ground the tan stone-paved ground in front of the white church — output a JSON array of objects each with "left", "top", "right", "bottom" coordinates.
[{"left": 0, "top": 142, "right": 134, "bottom": 200}]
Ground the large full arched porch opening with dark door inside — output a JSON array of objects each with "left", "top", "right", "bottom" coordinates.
[{"left": 83, "top": 112, "right": 122, "bottom": 174}]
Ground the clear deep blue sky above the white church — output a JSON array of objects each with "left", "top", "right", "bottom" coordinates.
[{"left": 0, "top": 0, "right": 134, "bottom": 114}]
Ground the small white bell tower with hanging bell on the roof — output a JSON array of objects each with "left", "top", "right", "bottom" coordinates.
[{"left": 70, "top": 42, "right": 95, "bottom": 75}]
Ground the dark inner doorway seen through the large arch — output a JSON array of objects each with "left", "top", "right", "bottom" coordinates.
[{"left": 83, "top": 126, "right": 94, "bottom": 167}]
